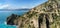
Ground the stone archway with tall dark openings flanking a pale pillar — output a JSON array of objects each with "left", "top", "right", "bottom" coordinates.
[{"left": 38, "top": 13, "right": 49, "bottom": 28}]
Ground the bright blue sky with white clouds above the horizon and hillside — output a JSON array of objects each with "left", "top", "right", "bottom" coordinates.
[{"left": 0, "top": 0, "right": 48, "bottom": 9}]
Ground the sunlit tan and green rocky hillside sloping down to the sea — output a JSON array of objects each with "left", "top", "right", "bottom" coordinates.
[{"left": 7, "top": 0, "right": 60, "bottom": 28}]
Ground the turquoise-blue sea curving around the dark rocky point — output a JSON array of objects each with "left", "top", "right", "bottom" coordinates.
[{"left": 0, "top": 10, "right": 29, "bottom": 28}]
